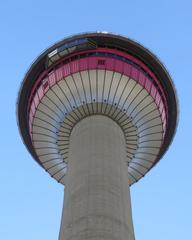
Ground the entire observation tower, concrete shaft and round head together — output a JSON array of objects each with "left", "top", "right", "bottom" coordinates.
[{"left": 18, "top": 32, "right": 177, "bottom": 240}]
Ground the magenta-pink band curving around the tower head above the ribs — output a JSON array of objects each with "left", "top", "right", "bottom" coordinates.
[{"left": 28, "top": 48, "right": 168, "bottom": 137}]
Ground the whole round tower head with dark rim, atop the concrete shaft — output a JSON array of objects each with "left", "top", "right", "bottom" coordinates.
[{"left": 18, "top": 33, "right": 177, "bottom": 184}]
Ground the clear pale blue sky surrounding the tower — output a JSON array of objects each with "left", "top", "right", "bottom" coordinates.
[{"left": 0, "top": 0, "right": 192, "bottom": 240}]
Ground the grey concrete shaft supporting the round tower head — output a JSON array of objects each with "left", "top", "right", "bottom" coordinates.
[{"left": 59, "top": 115, "right": 134, "bottom": 240}]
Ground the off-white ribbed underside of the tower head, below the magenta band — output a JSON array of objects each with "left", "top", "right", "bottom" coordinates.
[{"left": 32, "top": 70, "right": 163, "bottom": 184}]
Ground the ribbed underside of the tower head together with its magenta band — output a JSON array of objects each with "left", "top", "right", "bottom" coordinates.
[{"left": 29, "top": 54, "right": 167, "bottom": 184}]
